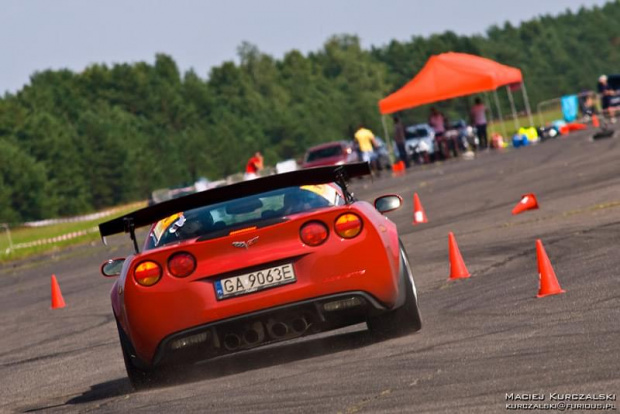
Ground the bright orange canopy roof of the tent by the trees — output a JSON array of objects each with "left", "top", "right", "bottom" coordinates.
[{"left": 379, "top": 52, "right": 523, "bottom": 114}]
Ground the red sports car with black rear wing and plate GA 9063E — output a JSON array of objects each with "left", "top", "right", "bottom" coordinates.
[{"left": 99, "top": 163, "right": 421, "bottom": 388}]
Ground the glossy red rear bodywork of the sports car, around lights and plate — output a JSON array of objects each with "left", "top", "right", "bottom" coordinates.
[{"left": 111, "top": 202, "right": 400, "bottom": 363}]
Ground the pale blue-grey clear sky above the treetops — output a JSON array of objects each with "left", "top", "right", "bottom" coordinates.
[{"left": 0, "top": 0, "right": 606, "bottom": 93}]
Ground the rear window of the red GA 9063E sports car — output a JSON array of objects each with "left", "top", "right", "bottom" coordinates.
[{"left": 146, "top": 184, "right": 344, "bottom": 250}]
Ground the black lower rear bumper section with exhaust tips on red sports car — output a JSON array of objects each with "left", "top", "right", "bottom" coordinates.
[{"left": 151, "top": 291, "right": 388, "bottom": 366}]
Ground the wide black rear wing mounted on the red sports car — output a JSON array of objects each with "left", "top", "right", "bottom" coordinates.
[{"left": 99, "top": 162, "right": 371, "bottom": 252}]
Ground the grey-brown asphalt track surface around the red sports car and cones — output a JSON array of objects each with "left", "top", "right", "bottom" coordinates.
[{"left": 0, "top": 127, "right": 620, "bottom": 413}]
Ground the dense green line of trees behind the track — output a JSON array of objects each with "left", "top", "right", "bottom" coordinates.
[{"left": 0, "top": 0, "right": 620, "bottom": 223}]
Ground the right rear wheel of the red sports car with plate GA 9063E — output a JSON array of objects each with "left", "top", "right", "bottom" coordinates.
[{"left": 367, "top": 243, "right": 422, "bottom": 338}]
